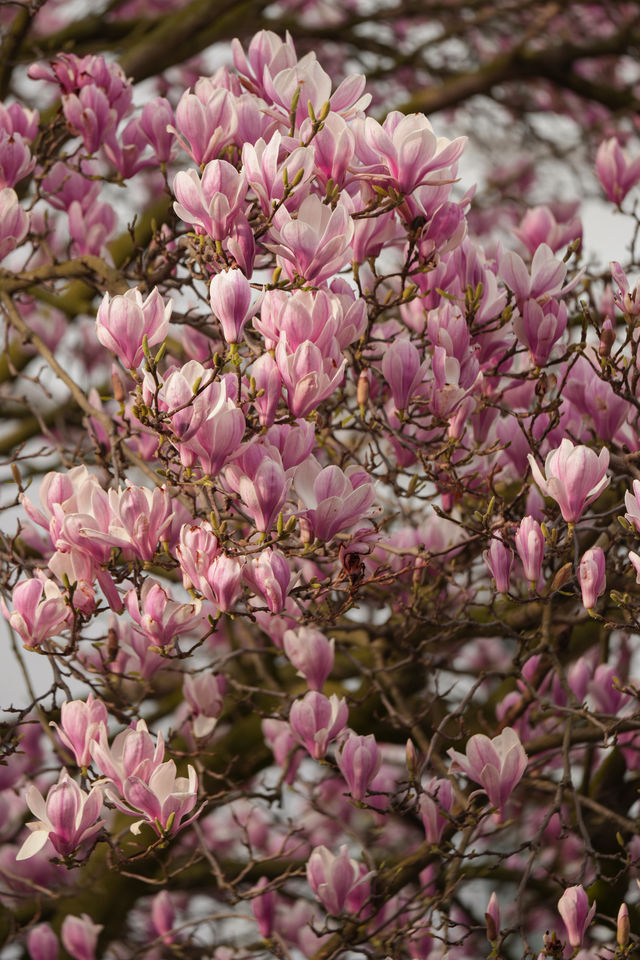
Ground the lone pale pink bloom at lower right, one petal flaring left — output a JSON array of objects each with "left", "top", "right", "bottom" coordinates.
[{"left": 447, "top": 727, "right": 527, "bottom": 813}]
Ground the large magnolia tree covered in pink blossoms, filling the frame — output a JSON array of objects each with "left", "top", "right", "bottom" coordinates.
[{"left": 0, "top": 3, "right": 640, "bottom": 960}]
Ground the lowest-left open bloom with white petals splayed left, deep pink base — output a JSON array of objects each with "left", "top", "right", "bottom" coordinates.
[{"left": 16, "top": 770, "right": 104, "bottom": 860}]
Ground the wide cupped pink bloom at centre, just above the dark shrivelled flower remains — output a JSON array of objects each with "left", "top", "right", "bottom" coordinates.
[{"left": 294, "top": 457, "right": 376, "bottom": 540}]
